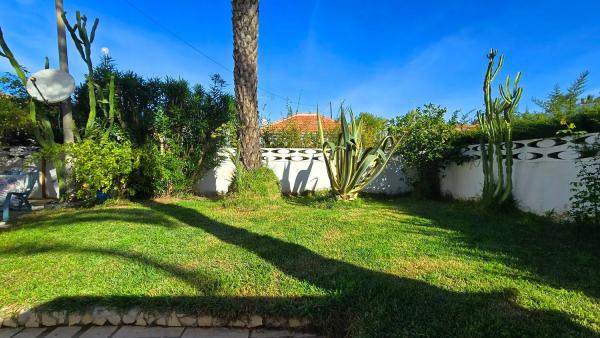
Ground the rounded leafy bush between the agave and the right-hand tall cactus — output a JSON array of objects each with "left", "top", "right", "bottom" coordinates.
[{"left": 388, "top": 104, "right": 457, "bottom": 198}]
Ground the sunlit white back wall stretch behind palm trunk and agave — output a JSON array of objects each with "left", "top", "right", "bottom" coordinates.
[{"left": 195, "top": 148, "right": 410, "bottom": 195}]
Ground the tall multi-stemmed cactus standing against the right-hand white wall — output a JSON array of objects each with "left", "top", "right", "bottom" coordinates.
[{"left": 477, "top": 49, "right": 523, "bottom": 205}]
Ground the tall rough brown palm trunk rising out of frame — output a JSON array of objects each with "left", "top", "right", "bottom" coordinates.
[{"left": 231, "top": 0, "right": 261, "bottom": 169}]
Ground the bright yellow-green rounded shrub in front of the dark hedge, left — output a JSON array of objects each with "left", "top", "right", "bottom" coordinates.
[{"left": 68, "top": 134, "right": 139, "bottom": 202}]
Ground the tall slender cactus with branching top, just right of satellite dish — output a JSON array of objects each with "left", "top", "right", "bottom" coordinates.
[{"left": 62, "top": 11, "right": 100, "bottom": 133}]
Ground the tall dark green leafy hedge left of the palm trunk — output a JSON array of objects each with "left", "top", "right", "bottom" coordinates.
[{"left": 74, "top": 57, "right": 235, "bottom": 197}]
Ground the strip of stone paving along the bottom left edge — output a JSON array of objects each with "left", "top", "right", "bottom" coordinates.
[{"left": 0, "top": 326, "right": 318, "bottom": 338}]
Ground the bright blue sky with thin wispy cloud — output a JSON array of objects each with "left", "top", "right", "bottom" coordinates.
[{"left": 0, "top": 0, "right": 600, "bottom": 119}]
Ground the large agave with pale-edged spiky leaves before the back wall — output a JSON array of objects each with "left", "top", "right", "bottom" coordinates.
[{"left": 317, "top": 105, "right": 399, "bottom": 201}]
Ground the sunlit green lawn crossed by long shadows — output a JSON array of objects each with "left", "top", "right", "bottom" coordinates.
[{"left": 0, "top": 197, "right": 600, "bottom": 337}]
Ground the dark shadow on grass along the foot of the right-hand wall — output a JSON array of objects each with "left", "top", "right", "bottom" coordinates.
[{"left": 380, "top": 199, "right": 600, "bottom": 299}]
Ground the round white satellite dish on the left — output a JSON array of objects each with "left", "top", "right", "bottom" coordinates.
[{"left": 27, "top": 69, "right": 75, "bottom": 103}]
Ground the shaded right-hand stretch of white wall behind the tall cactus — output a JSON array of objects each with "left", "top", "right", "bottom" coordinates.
[{"left": 440, "top": 133, "right": 598, "bottom": 215}]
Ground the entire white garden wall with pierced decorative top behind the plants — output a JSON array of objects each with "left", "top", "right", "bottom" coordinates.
[{"left": 195, "top": 133, "right": 598, "bottom": 214}]
